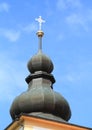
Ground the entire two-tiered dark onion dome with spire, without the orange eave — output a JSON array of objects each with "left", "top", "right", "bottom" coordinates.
[{"left": 10, "top": 17, "right": 71, "bottom": 122}]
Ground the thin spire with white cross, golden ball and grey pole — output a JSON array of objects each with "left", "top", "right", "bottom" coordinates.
[{"left": 35, "top": 16, "right": 45, "bottom": 52}]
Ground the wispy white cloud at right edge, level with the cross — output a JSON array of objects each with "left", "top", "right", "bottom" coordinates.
[{"left": 65, "top": 9, "right": 92, "bottom": 32}]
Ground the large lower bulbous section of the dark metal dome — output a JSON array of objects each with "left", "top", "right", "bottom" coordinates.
[{"left": 10, "top": 79, "right": 71, "bottom": 121}]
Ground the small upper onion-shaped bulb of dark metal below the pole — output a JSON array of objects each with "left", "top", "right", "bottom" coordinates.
[{"left": 28, "top": 51, "right": 53, "bottom": 73}]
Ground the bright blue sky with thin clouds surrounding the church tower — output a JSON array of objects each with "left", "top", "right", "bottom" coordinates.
[{"left": 0, "top": 0, "right": 92, "bottom": 130}]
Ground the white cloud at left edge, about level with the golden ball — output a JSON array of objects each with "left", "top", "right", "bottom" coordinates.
[{"left": 0, "top": 29, "right": 20, "bottom": 42}]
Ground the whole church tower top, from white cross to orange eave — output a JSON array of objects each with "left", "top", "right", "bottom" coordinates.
[{"left": 5, "top": 16, "right": 90, "bottom": 130}]
